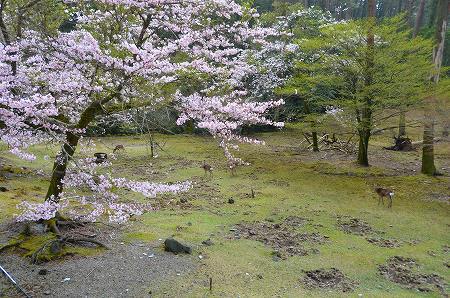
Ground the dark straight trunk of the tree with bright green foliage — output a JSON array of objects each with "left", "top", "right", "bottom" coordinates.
[{"left": 358, "top": 0, "right": 376, "bottom": 167}]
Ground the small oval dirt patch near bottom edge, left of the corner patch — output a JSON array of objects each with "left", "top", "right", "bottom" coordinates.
[{"left": 302, "top": 268, "right": 357, "bottom": 292}]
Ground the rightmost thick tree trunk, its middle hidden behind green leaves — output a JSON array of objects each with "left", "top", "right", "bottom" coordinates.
[{"left": 422, "top": 0, "right": 449, "bottom": 175}]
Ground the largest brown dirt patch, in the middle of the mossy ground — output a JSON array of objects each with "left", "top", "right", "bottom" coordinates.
[{"left": 232, "top": 216, "right": 327, "bottom": 258}]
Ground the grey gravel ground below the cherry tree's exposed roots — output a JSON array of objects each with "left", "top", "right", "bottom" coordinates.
[{"left": 0, "top": 243, "right": 195, "bottom": 297}]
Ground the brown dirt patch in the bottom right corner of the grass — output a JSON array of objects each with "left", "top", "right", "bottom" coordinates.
[{"left": 378, "top": 256, "right": 445, "bottom": 296}]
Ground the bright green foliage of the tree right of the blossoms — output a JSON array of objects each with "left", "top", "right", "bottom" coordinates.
[{"left": 280, "top": 16, "right": 432, "bottom": 130}]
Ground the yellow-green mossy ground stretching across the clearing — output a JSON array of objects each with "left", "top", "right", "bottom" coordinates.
[{"left": 0, "top": 128, "right": 450, "bottom": 297}]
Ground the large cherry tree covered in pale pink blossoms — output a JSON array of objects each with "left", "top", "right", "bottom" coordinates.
[{"left": 0, "top": 0, "right": 283, "bottom": 234}]
